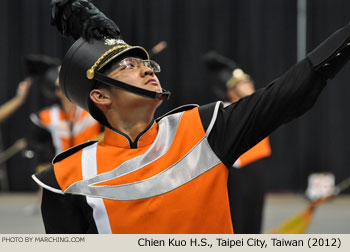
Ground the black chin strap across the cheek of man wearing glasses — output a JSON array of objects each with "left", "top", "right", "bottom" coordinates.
[{"left": 94, "top": 72, "right": 170, "bottom": 100}]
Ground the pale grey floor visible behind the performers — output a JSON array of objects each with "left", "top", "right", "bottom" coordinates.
[{"left": 0, "top": 193, "right": 350, "bottom": 234}]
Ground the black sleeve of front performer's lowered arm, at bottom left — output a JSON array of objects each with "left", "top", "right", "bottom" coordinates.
[{"left": 41, "top": 189, "right": 97, "bottom": 234}]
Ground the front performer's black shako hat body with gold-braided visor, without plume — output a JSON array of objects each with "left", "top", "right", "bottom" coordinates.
[{"left": 59, "top": 38, "right": 148, "bottom": 111}]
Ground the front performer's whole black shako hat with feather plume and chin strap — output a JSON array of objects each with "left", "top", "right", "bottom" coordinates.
[{"left": 51, "top": 0, "right": 170, "bottom": 126}]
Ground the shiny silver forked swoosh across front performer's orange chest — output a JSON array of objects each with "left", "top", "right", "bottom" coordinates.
[{"left": 65, "top": 113, "right": 221, "bottom": 200}]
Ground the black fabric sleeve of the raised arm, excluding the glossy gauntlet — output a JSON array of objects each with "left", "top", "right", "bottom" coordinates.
[{"left": 199, "top": 59, "right": 326, "bottom": 167}]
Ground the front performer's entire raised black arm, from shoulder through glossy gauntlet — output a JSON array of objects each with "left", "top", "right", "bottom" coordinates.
[{"left": 199, "top": 23, "right": 350, "bottom": 167}]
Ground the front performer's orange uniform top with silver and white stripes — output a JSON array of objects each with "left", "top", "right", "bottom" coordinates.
[{"left": 33, "top": 105, "right": 233, "bottom": 233}]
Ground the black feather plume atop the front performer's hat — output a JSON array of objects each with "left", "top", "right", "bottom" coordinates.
[{"left": 51, "top": 0, "right": 120, "bottom": 41}]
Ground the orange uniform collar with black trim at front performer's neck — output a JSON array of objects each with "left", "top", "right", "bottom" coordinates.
[{"left": 104, "top": 120, "right": 158, "bottom": 149}]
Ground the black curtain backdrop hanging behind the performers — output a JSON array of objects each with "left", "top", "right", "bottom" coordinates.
[{"left": 0, "top": 0, "right": 350, "bottom": 192}]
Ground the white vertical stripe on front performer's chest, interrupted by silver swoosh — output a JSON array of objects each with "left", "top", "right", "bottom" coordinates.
[{"left": 81, "top": 143, "right": 112, "bottom": 234}]
